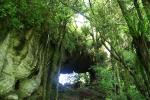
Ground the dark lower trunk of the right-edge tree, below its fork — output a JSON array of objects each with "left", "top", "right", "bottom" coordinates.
[{"left": 133, "top": 37, "right": 150, "bottom": 97}]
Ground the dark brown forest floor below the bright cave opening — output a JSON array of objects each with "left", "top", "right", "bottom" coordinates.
[{"left": 58, "top": 87, "right": 105, "bottom": 100}]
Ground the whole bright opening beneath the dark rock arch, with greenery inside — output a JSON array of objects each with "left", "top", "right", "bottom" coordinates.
[{"left": 59, "top": 72, "right": 90, "bottom": 91}]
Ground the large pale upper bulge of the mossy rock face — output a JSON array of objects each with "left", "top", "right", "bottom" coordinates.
[{"left": 0, "top": 34, "right": 34, "bottom": 79}]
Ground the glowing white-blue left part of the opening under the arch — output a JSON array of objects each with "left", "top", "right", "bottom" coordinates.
[{"left": 59, "top": 72, "right": 78, "bottom": 85}]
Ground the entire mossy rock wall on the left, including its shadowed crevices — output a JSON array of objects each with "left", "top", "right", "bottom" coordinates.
[{"left": 0, "top": 29, "right": 53, "bottom": 100}]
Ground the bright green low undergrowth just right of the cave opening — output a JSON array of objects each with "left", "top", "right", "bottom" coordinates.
[{"left": 94, "top": 65, "right": 145, "bottom": 100}]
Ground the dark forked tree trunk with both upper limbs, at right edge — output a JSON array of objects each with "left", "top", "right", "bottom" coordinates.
[{"left": 117, "top": 0, "right": 150, "bottom": 97}]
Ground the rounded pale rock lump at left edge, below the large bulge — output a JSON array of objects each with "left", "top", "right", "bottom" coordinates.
[{"left": 0, "top": 75, "right": 15, "bottom": 95}]
